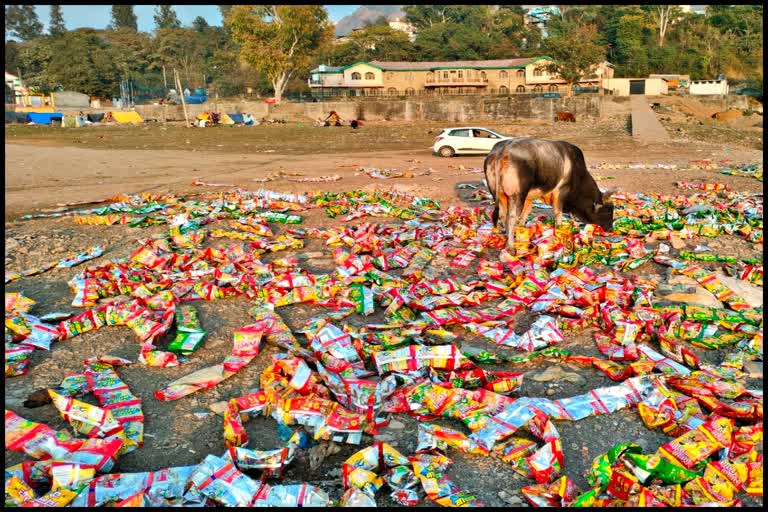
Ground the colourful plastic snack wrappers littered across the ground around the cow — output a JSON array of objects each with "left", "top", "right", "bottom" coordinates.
[{"left": 5, "top": 179, "right": 763, "bottom": 507}]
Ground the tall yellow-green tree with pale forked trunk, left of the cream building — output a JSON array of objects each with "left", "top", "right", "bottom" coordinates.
[{"left": 225, "top": 5, "right": 334, "bottom": 101}]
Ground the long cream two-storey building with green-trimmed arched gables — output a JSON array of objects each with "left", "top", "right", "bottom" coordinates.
[{"left": 309, "top": 56, "right": 613, "bottom": 96}]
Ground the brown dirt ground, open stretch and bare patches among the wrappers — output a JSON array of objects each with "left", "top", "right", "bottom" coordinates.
[{"left": 5, "top": 118, "right": 763, "bottom": 506}]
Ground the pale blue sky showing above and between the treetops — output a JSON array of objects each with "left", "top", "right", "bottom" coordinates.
[{"left": 35, "top": 5, "right": 360, "bottom": 32}]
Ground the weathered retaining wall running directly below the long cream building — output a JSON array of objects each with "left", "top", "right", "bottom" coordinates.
[{"left": 304, "top": 96, "right": 608, "bottom": 122}]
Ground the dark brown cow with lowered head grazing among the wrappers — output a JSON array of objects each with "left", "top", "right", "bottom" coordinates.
[{"left": 483, "top": 137, "right": 613, "bottom": 253}]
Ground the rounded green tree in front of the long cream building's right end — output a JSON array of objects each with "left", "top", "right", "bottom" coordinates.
[{"left": 543, "top": 21, "right": 605, "bottom": 94}]
